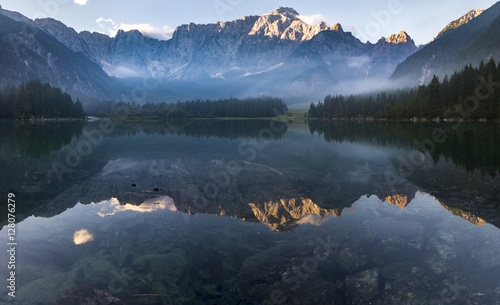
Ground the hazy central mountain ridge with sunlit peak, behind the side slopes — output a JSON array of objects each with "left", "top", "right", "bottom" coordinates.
[{"left": 0, "top": 7, "right": 422, "bottom": 97}]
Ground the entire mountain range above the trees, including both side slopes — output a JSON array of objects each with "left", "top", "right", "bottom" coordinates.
[{"left": 0, "top": 4, "right": 500, "bottom": 102}]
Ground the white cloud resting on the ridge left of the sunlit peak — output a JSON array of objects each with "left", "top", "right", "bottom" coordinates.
[{"left": 95, "top": 16, "right": 174, "bottom": 40}]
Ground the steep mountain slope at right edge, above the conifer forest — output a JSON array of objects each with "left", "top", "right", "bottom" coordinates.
[{"left": 391, "top": 2, "right": 500, "bottom": 84}]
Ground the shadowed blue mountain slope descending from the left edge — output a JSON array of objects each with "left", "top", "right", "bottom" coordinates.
[{"left": 0, "top": 10, "right": 117, "bottom": 96}]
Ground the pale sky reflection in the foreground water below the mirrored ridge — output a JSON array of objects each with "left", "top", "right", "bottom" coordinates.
[{"left": 2, "top": 193, "right": 500, "bottom": 304}]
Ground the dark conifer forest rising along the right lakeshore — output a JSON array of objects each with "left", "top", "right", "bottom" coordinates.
[{"left": 308, "top": 59, "right": 500, "bottom": 120}]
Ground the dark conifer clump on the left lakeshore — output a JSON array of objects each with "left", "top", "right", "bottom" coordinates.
[{"left": 0, "top": 80, "right": 84, "bottom": 119}]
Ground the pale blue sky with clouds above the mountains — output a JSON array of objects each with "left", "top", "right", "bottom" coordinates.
[{"left": 0, "top": 0, "right": 496, "bottom": 45}]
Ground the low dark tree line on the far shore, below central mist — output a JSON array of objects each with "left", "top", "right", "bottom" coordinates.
[{"left": 86, "top": 96, "right": 288, "bottom": 119}]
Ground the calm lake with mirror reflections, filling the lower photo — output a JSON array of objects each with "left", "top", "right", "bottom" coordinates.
[{"left": 0, "top": 120, "right": 500, "bottom": 305}]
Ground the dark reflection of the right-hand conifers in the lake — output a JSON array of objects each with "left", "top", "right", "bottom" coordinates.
[{"left": 308, "top": 120, "right": 500, "bottom": 178}]
